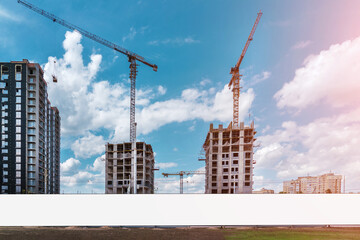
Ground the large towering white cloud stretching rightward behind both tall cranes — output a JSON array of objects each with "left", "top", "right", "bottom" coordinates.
[{"left": 44, "top": 31, "right": 255, "bottom": 144}]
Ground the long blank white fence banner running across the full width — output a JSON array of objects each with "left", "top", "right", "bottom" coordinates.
[{"left": 0, "top": 194, "right": 360, "bottom": 226}]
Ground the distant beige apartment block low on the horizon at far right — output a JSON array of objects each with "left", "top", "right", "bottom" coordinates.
[{"left": 283, "top": 173, "right": 342, "bottom": 194}]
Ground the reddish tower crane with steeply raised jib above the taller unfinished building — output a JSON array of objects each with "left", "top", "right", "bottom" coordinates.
[{"left": 228, "top": 11, "right": 262, "bottom": 127}]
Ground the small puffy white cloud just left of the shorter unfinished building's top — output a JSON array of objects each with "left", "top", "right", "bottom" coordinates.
[{"left": 71, "top": 133, "right": 105, "bottom": 158}]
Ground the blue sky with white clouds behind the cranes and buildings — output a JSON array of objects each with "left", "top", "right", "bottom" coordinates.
[{"left": 0, "top": 0, "right": 360, "bottom": 193}]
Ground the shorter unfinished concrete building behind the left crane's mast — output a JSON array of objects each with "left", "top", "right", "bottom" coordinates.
[{"left": 105, "top": 142, "right": 155, "bottom": 194}]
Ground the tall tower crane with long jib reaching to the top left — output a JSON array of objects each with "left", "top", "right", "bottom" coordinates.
[{"left": 18, "top": 0, "right": 158, "bottom": 193}]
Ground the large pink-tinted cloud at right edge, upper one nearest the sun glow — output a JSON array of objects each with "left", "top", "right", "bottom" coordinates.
[{"left": 274, "top": 37, "right": 360, "bottom": 110}]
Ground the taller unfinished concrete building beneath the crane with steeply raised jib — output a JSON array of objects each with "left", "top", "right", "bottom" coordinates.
[{"left": 203, "top": 122, "right": 256, "bottom": 194}]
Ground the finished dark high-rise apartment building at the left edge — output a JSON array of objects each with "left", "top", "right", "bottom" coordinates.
[{"left": 0, "top": 59, "right": 60, "bottom": 194}]
